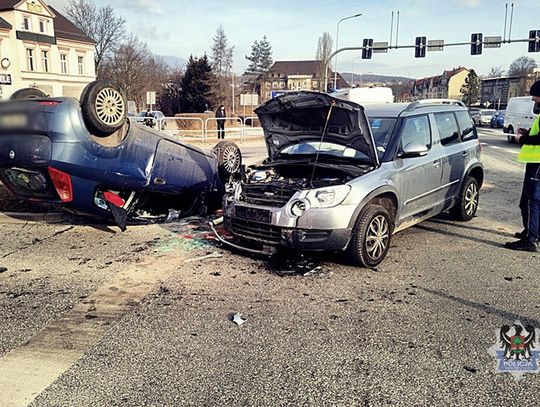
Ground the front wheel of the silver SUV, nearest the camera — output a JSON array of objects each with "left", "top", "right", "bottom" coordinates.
[{"left": 347, "top": 204, "right": 394, "bottom": 268}]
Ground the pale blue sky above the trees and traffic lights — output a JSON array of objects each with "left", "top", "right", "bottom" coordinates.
[{"left": 49, "top": 0, "right": 540, "bottom": 77}]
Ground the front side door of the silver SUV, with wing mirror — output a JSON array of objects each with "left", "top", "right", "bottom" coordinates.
[{"left": 395, "top": 114, "right": 441, "bottom": 221}]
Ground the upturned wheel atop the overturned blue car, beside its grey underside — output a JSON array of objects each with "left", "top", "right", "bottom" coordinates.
[{"left": 80, "top": 80, "right": 127, "bottom": 137}]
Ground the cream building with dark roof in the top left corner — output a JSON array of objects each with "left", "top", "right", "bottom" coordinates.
[{"left": 0, "top": 0, "right": 96, "bottom": 99}]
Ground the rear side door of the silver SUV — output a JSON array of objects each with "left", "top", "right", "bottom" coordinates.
[{"left": 433, "top": 111, "right": 462, "bottom": 204}]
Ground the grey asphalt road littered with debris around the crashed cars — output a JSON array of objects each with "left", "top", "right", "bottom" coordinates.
[{"left": 0, "top": 129, "right": 540, "bottom": 406}]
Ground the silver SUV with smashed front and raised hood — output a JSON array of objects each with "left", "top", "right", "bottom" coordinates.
[{"left": 224, "top": 92, "right": 484, "bottom": 267}]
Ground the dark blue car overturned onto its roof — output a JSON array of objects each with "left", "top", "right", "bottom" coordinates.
[{"left": 0, "top": 81, "right": 241, "bottom": 230}]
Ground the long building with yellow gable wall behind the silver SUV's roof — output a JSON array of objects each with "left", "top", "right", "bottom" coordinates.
[{"left": 410, "top": 66, "right": 470, "bottom": 100}]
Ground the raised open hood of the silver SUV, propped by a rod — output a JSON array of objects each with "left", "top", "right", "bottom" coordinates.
[{"left": 255, "top": 92, "right": 379, "bottom": 166}]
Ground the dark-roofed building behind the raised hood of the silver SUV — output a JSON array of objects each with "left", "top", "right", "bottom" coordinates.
[{"left": 258, "top": 60, "right": 349, "bottom": 101}]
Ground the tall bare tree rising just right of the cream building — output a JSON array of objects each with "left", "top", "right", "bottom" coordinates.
[{"left": 66, "top": 0, "right": 126, "bottom": 73}]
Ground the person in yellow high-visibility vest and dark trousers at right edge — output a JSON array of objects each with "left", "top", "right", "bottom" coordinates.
[{"left": 504, "top": 81, "right": 540, "bottom": 252}]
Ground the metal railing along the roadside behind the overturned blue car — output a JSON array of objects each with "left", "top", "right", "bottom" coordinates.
[{"left": 133, "top": 116, "right": 262, "bottom": 142}]
